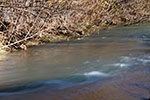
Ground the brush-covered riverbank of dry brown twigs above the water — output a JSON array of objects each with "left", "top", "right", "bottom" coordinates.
[{"left": 0, "top": 0, "right": 150, "bottom": 51}]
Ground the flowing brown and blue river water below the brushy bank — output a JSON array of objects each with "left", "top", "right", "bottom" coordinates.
[{"left": 0, "top": 24, "right": 150, "bottom": 100}]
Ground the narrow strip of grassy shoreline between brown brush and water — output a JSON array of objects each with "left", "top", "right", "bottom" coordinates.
[{"left": 0, "top": 21, "right": 150, "bottom": 55}]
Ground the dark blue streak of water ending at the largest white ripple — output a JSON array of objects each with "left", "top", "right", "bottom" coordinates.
[{"left": 0, "top": 72, "right": 108, "bottom": 94}]
